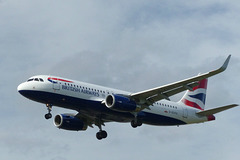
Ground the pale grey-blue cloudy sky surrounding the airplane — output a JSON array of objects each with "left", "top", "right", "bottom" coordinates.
[{"left": 0, "top": 0, "right": 240, "bottom": 160}]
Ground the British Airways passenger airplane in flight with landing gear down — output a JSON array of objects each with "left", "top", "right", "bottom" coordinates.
[{"left": 17, "top": 55, "right": 238, "bottom": 140}]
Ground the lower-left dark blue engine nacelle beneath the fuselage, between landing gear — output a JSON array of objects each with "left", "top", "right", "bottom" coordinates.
[{"left": 54, "top": 114, "right": 88, "bottom": 131}]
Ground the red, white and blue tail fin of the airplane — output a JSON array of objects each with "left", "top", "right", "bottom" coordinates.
[{"left": 179, "top": 79, "right": 208, "bottom": 110}]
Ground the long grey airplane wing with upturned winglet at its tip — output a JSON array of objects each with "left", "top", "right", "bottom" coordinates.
[{"left": 130, "top": 55, "right": 231, "bottom": 106}]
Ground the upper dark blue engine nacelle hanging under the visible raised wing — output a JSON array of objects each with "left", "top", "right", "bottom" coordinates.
[{"left": 105, "top": 95, "right": 140, "bottom": 112}]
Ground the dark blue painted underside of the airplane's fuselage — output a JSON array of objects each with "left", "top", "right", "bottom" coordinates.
[{"left": 19, "top": 90, "right": 186, "bottom": 125}]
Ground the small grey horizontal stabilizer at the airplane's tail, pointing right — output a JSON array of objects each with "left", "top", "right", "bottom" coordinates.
[{"left": 196, "top": 104, "right": 238, "bottom": 116}]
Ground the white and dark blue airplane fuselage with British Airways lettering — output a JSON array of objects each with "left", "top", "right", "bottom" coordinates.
[{"left": 18, "top": 75, "right": 212, "bottom": 125}]
